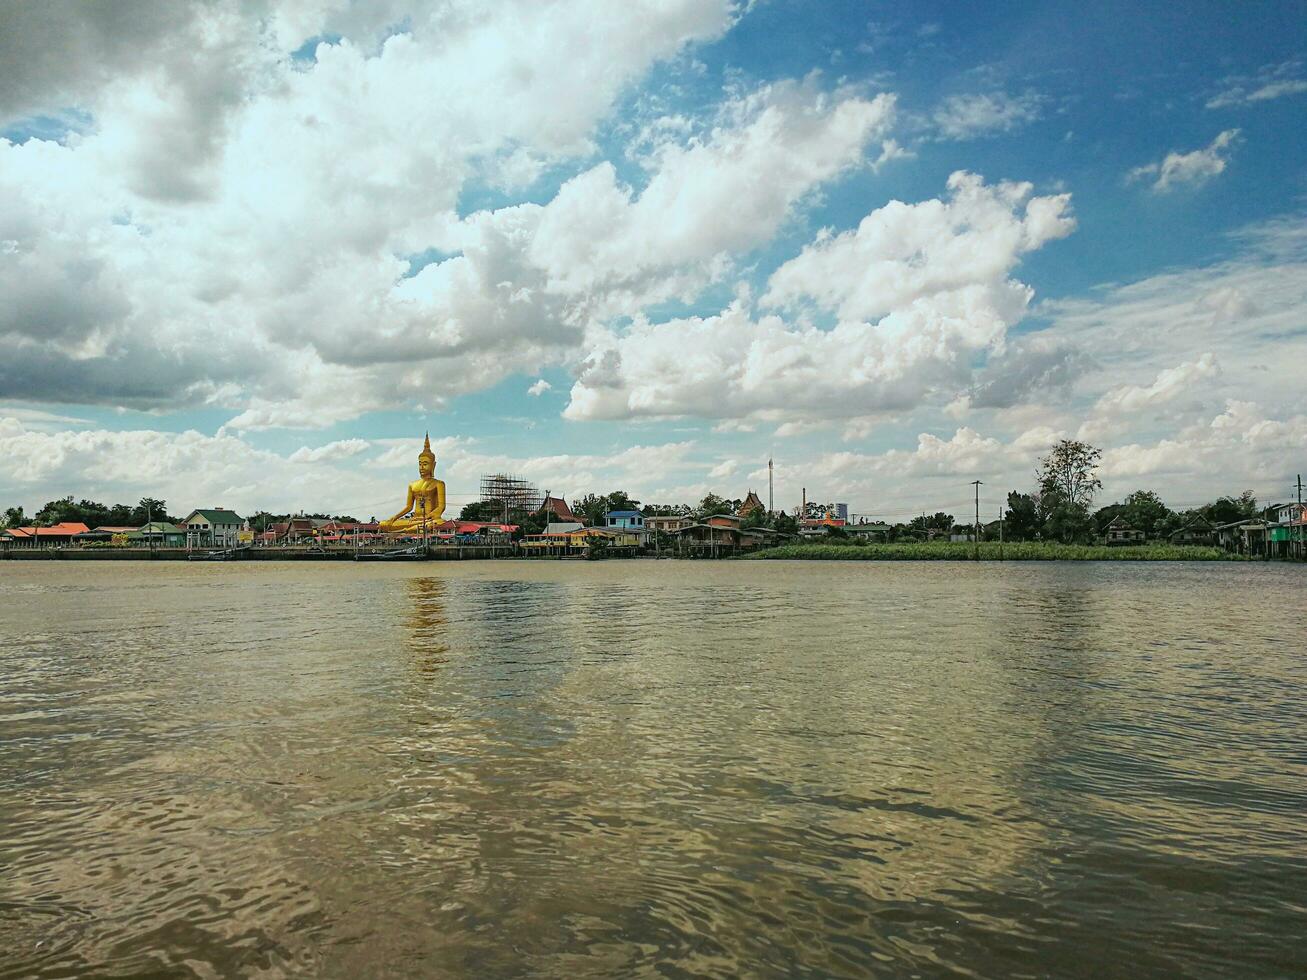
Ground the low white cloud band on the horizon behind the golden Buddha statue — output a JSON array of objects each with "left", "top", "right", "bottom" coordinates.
[{"left": 0, "top": 417, "right": 715, "bottom": 516}]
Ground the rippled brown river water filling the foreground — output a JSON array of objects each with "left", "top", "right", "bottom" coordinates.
[{"left": 0, "top": 561, "right": 1307, "bottom": 979}]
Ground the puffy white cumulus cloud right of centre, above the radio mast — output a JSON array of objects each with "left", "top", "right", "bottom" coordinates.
[{"left": 566, "top": 172, "right": 1074, "bottom": 423}]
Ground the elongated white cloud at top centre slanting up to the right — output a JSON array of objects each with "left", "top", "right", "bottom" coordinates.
[{"left": 528, "top": 80, "right": 894, "bottom": 303}]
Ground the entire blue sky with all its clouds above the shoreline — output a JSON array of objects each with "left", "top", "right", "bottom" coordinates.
[{"left": 0, "top": 0, "right": 1307, "bottom": 519}]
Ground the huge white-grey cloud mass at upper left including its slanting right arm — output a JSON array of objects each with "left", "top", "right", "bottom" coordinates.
[{"left": 0, "top": 17, "right": 893, "bottom": 430}]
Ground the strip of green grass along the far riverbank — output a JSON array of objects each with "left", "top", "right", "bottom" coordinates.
[{"left": 742, "top": 541, "right": 1240, "bottom": 562}]
